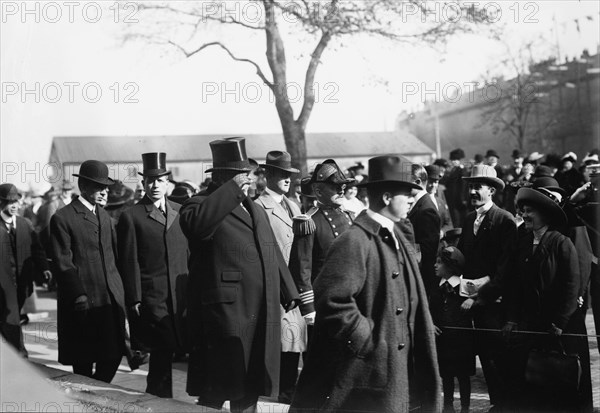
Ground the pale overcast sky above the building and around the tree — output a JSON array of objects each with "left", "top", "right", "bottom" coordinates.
[{"left": 0, "top": 0, "right": 600, "bottom": 187}]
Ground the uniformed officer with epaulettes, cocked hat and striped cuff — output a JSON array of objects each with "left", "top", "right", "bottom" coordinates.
[{"left": 290, "top": 159, "right": 354, "bottom": 324}]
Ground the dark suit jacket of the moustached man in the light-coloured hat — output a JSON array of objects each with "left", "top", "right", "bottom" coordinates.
[{"left": 458, "top": 205, "right": 517, "bottom": 304}]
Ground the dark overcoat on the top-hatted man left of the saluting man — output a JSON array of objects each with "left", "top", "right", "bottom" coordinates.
[{"left": 117, "top": 197, "right": 188, "bottom": 349}]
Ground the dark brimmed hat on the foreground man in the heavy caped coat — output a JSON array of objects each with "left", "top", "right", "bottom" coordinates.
[{"left": 357, "top": 155, "right": 422, "bottom": 189}]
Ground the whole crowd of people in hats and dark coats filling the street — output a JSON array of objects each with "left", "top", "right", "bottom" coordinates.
[{"left": 0, "top": 137, "right": 600, "bottom": 412}]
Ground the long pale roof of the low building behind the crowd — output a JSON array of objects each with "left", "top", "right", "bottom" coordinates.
[{"left": 51, "top": 131, "right": 434, "bottom": 163}]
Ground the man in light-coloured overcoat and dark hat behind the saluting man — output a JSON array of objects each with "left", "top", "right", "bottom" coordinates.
[{"left": 254, "top": 151, "right": 306, "bottom": 404}]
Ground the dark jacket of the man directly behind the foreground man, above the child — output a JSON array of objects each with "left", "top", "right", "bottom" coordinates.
[{"left": 408, "top": 194, "right": 441, "bottom": 293}]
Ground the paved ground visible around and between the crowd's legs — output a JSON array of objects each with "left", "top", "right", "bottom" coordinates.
[{"left": 8, "top": 288, "right": 600, "bottom": 413}]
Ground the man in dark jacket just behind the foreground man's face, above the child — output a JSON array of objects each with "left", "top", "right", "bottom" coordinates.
[{"left": 405, "top": 163, "right": 442, "bottom": 293}]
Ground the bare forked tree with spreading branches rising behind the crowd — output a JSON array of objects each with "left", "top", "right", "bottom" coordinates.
[{"left": 124, "top": 0, "right": 490, "bottom": 174}]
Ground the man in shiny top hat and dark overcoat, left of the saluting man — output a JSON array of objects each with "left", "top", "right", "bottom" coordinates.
[{"left": 117, "top": 152, "right": 188, "bottom": 397}]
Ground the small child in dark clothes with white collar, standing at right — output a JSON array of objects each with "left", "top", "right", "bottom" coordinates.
[{"left": 430, "top": 246, "right": 475, "bottom": 413}]
